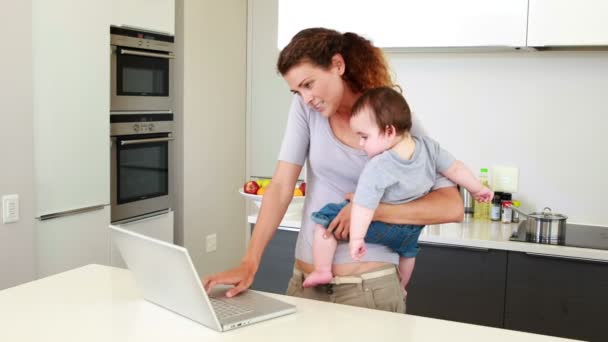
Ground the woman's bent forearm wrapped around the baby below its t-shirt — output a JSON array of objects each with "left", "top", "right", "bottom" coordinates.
[{"left": 374, "top": 186, "right": 464, "bottom": 225}]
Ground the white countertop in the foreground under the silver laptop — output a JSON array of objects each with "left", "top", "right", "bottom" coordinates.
[{"left": 0, "top": 265, "right": 576, "bottom": 342}]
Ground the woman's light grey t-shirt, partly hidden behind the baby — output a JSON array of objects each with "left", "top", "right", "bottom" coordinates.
[{"left": 279, "top": 95, "right": 454, "bottom": 264}]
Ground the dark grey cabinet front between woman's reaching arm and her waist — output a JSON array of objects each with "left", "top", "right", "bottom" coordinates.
[{"left": 251, "top": 227, "right": 298, "bottom": 294}]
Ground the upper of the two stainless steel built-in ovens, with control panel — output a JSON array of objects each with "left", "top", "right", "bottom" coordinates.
[{"left": 110, "top": 26, "right": 175, "bottom": 112}]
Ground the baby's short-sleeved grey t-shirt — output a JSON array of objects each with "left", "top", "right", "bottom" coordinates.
[{"left": 353, "top": 136, "right": 454, "bottom": 209}]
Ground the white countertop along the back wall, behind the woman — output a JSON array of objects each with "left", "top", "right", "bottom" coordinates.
[{"left": 247, "top": 215, "right": 608, "bottom": 262}]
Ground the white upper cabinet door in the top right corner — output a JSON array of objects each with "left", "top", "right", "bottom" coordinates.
[{"left": 528, "top": 0, "right": 608, "bottom": 46}]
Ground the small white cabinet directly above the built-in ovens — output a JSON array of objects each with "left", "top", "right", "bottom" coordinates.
[{"left": 112, "top": 0, "right": 175, "bottom": 35}]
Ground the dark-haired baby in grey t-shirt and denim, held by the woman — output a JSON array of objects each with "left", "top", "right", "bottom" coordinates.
[{"left": 303, "top": 87, "right": 494, "bottom": 290}]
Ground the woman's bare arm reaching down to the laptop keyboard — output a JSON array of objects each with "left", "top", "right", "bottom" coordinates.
[{"left": 203, "top": 161, "right": 302, "bottom": 297}]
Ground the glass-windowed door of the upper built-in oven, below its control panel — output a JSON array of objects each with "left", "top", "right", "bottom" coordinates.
[{"left": 110, "top": 46, "right": 174, "bottom": 111}]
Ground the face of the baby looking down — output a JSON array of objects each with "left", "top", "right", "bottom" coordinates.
[{"left": 350, "top": 108, "right": 391, "bottom": 158}]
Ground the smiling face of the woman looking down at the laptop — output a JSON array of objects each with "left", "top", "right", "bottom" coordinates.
[{"left": 283, "top": 57, "right": 344, "bottom": 117}]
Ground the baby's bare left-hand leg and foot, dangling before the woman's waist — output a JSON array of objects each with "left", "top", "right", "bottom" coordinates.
[{"left": 302, "top": 224, "right": 338, "bottom": 287}]
